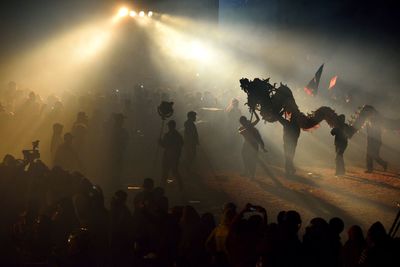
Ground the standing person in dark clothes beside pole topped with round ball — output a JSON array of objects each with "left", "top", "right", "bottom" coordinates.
[{"left": 159, "top": 120, "right": 183, "bottom": 190}]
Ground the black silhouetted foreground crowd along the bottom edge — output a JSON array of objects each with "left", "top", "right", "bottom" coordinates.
[{"left": 0, "top": 156, "right": 400, "bottom": 267}]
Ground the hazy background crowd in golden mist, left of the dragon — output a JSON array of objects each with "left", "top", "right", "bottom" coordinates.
[{"left": 0, "top": 82, "right": 241, "bottom": 190}]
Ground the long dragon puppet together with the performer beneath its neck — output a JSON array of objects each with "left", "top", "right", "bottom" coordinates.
[{"left": 240, "top": 78, "right": 400, "bottom": 174}]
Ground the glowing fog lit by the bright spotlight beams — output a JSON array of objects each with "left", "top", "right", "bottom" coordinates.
[{"left": 0, "top": 0, "right": 400, "bottom": 195}]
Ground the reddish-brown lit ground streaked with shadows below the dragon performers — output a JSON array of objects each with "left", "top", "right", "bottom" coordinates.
[{"left": 167, "top": 166, "right": 400, "bottom": 237}]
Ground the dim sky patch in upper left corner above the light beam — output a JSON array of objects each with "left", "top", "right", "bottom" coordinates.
[{"left": 0, "top": 0, "right": 106, "bottom": 50}]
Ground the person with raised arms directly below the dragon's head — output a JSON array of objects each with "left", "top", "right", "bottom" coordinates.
[{"left": 239, "top": 112, "right": 266, "bottom": 178}]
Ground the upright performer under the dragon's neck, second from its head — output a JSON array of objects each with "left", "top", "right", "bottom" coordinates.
[{"left": 279, "top": 113, "right": 300, "bottom": 175}]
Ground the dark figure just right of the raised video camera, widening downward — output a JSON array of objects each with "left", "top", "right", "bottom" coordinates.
[{"left": 54, "top": 133, "right": 82, "bottom": 172}]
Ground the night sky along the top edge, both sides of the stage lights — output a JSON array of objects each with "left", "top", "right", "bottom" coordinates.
[{"left": 0, "top": 0, "right": 400, "bottom": 59}]
